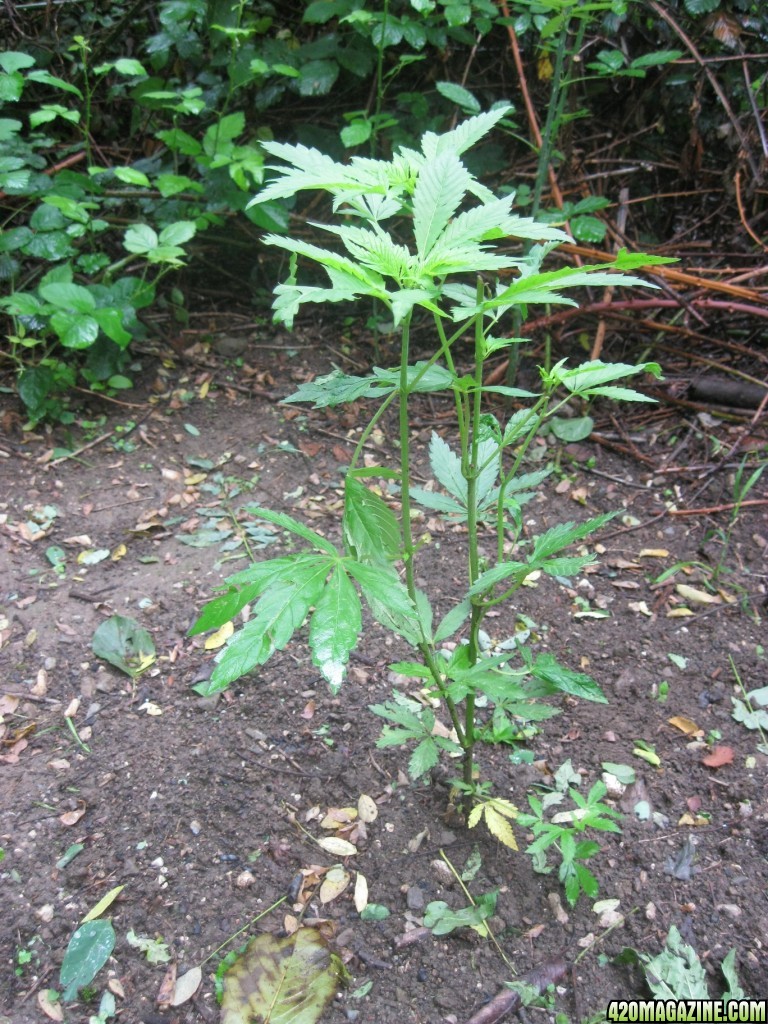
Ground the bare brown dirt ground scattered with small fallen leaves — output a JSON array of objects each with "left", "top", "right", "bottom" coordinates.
[{"left": 0, "top": 333, "right": 768, "bottom": 1024}]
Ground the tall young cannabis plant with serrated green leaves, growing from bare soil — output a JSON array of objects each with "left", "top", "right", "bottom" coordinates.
[{"left": 193, "top": 105, "right": 665, "bottom": 842}]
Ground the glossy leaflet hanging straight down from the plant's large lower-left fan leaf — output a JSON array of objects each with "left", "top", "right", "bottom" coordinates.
[{"left": 309, "top": 565, "right": 362, "bottom": 693}]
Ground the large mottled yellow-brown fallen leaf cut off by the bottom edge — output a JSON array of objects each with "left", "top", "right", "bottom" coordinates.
[{"left": 221, "top": 928, "right": 343, "bottom": 1024}]
